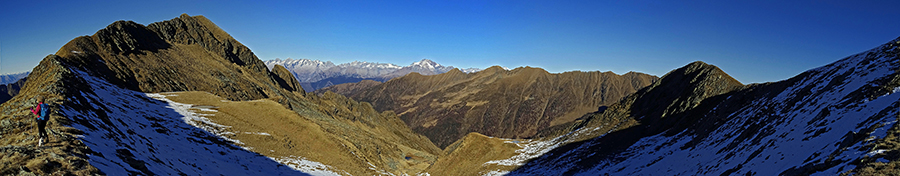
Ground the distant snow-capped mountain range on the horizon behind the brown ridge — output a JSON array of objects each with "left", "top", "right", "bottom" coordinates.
[{"left": 264, "top": 58, "right": 481, "bottom": 92}]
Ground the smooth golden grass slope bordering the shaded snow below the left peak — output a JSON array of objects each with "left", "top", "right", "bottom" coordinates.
[{"left": 163, "top": 91, "right": 375, "bottom": 175}]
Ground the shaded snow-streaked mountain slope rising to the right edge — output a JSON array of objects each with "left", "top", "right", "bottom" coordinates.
[{"left": 500, "top": 39, "right": 900, "bottom": 175}]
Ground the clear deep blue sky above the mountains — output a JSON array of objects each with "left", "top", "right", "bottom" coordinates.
[{"left": 0, "top": 0, "right": 900, "bottom": 83}]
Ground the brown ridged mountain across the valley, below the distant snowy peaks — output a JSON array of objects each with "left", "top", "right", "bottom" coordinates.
[{"left": 349, "top": 66, "right": 657, "bottom": 148}]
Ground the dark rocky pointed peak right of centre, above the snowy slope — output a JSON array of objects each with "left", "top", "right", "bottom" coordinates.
[{"left": 538, "top": 61, "right": 744, "bottom": 141}]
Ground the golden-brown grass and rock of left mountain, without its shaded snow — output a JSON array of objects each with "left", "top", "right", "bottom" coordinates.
[{"left": 0, "top": 15, "right": 440, "bottom": 175}]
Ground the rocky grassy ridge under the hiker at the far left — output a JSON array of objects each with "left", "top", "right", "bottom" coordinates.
[{"left": 0, "top": 55, "right": 103, "bottom": 175}]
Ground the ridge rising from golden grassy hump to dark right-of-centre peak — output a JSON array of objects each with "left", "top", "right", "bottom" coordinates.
[{"left": 426, "top": 62, "right": 743, "bottom": 175}]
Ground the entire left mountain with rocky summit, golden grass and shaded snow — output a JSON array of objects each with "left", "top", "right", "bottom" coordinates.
[{"left": 0, "top": 15, "right": 440, "bottom": 175}]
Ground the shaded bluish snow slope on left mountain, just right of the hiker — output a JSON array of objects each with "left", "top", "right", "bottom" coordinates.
[{"left": 58, "top": 72, "right": 309, "bottom": 175}]
